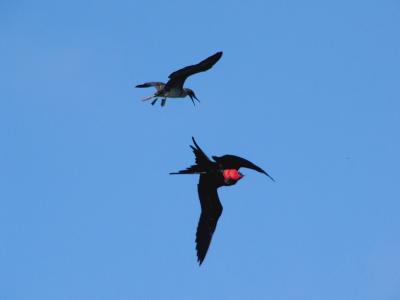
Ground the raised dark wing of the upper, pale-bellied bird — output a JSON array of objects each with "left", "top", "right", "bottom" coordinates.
[{"left": 166, "top": 52, "right": 222, "bottom": 89}]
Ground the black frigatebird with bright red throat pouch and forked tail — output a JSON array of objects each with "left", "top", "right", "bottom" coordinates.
[{"left": 170, "top": 137, "right": 274, "bottom": 265}]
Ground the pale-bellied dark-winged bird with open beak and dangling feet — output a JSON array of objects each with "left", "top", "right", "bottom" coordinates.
[{"left": 136, "top": 52, "right": 222, "bottom": 106}]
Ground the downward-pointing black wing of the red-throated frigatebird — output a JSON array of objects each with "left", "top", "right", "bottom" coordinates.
[{"left": 196, "top": 174, "right": 222, "bottom": 265}]
